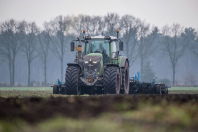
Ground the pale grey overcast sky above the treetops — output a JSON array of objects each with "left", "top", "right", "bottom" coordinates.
[{"left": 0, "top": 0, "right": 198, "bottom": 28}]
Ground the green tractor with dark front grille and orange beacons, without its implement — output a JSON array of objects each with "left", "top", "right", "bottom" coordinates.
[{"left": 65, "top": 30, "right": 129, "bottom": 95}]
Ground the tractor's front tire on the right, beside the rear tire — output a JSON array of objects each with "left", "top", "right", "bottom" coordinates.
[{"left": 104, "top": 67, "right": 120, "bottom": 94}]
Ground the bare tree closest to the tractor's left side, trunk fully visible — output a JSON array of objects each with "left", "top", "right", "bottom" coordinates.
[{"left": 48, "top": 16, "right": 71, "bottom": 80}]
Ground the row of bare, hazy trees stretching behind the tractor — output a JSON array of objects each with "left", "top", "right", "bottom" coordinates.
[{"left": 0, "top": 13, "right": 198, "bottom": 86}]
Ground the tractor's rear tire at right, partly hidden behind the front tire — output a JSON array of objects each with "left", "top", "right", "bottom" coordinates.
[{"left": 121, "top": 61, "right": 129, "bottom": 94}]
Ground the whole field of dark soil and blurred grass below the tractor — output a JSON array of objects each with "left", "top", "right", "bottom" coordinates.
[{"left": 0, "top": 90, "right": 198, "bottom": 132}]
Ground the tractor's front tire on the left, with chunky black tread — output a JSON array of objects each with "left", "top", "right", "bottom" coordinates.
[{"left": 65, "top": 66, "right": 81, "bottom": 95}]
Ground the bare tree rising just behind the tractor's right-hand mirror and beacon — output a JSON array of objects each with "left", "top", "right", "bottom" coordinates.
[{"left": 120, "top": 15, "right": 140, "bottom": 66}]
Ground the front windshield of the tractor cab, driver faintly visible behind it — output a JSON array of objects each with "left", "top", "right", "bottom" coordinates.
[{"left": 86, "top": 40, "right": 109, "bottom": 56}]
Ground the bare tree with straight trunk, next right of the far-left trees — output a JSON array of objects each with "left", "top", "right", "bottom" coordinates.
[{"left": 20, "top": 21, "right": 39, "bottom": 86}]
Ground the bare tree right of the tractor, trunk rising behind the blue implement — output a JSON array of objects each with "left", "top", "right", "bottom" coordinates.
[{"left": 138, "top": 21, "right": 159, "bottom": 76}]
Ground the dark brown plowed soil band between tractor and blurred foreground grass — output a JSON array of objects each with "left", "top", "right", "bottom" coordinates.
[{"left": 0, "top": 95, "right": 198, "bottom": 123}]
